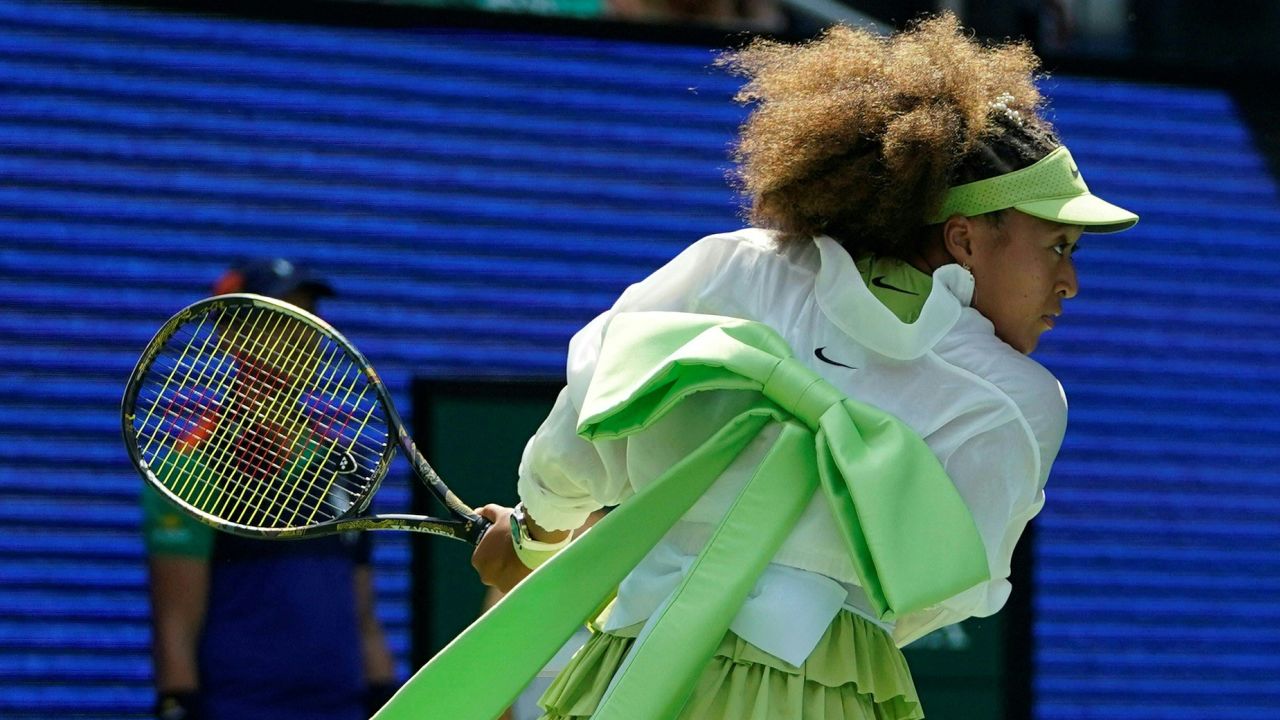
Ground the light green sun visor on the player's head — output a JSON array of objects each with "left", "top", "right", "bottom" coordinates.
[{"left": 929, "top": 147, "right": 1138, "bottom": 233}]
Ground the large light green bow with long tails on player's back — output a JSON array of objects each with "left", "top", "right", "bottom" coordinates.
[{"left": 375, "top": 313, "right": 989, "bottom": 720}]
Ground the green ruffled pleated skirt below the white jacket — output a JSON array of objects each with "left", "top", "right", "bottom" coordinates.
[{"left": 539, "top": 611, "right": 924, "bottom": 720}]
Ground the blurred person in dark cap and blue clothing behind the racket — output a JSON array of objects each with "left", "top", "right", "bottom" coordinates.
[{"left": 142, "top": 258, "right": 397, "bottom": 720}]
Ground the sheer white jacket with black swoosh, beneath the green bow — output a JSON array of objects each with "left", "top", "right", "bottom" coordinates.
[{"left": 518, "top": 229, "right": 1066, "bottom": 650}]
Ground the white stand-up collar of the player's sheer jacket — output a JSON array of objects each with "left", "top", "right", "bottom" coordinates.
[{"left": 814, "top": 236, "right": 973, "bottom": 360}]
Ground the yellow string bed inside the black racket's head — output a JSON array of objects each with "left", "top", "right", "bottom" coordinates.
[{"left": 138, "top": 302, "right": 388, "bottom": 527}]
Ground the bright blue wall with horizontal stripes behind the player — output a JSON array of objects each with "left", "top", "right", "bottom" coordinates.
[{"left": 0, "top": 0, "right": 1280, "bottom": 720}]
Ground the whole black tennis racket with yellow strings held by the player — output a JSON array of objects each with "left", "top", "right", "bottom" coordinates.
[{"left": 122, "top": 295, "right": 489, "bottom": 544}]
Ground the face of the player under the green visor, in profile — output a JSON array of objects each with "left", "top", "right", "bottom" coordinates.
[{"left": 968, "top": 210, "right": 1083, "bottom": 354}]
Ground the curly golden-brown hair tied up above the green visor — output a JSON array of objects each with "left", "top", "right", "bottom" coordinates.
[{"left": 717, "top": 13, "right": 1059, "bottom": 258}]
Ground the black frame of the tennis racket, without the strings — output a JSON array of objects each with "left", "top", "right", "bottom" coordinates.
[{"left": 120, "top": 293, "right": 490, "bottom": 544}]
